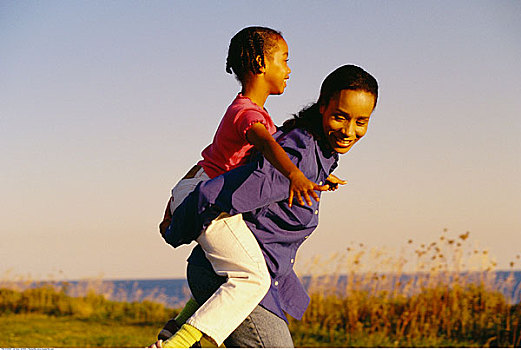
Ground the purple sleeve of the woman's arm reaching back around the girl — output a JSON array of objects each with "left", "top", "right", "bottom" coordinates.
[{"left": 164, "top": 130, "right": 317, "bottom": 247}]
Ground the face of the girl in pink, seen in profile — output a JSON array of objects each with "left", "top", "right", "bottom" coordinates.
[{"left": 264, "top": 37, "right": 291, "bottom": 95}]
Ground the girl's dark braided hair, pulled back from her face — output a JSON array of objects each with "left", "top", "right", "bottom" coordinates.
[{"left": 226, "top": 27, "right": 282, "bottom": 84}]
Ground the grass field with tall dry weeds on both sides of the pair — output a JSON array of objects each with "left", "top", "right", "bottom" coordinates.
[{"left": 0, "top": 233, "right": 521, "bottom": 348}]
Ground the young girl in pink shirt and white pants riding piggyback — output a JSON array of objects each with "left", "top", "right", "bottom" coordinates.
[{"left": 158, "top": 27, "right": 345, "bottom": 347}]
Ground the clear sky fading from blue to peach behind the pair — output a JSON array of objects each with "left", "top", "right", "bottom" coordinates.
[{"left": 0, "top": 1, "right": 521, "bottom": 278}]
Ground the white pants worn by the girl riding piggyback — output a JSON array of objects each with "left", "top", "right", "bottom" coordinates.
[{"left": 170, "top": 169, "right": 271, "bottom": 345}]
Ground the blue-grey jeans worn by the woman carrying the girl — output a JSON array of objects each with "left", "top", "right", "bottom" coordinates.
[{"left": 187, "top": 263, "right": 293, "bottom": 348}]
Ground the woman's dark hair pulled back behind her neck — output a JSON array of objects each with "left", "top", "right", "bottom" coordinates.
[{"left": 282, "top": 65, "right": 378, "bottom": 139}]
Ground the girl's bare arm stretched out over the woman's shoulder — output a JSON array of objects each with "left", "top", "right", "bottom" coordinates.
[{"left": 246, "top": 123, "right": 329, "bottom": 207}]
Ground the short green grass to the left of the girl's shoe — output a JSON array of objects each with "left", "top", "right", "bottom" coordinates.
[{"left": 0, "top": 314, "right": 163, "bottom": 348}]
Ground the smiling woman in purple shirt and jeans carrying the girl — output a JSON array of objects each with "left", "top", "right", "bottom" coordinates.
[{"left": 165, "top": 65, "right": 378, "bottom": 347}]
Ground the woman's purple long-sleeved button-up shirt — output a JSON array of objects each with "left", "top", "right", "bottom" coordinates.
[{"left": 165, "top": 129, "right": 338, "bottom": 320}]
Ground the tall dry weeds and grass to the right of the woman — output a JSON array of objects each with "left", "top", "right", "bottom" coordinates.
[{"left": 291, "top": 230, "right": 521, "bottom": 347}]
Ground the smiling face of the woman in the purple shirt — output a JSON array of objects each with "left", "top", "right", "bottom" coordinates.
[{"left": 320, "top": 90, "right": 375, "bottom": 154}]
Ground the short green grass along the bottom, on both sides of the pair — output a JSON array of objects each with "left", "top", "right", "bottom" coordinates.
[{"left": 0, "top": 314, "right": 486, "bottom": 348}]
